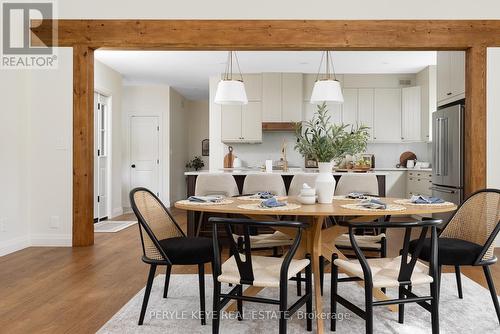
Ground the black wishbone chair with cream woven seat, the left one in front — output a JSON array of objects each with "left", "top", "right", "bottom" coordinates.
[{"left": 209, "top": 217, "right": 312, "bottom": 334}]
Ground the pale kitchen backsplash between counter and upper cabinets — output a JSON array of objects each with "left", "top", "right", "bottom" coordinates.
[{"left": 225, "top": 132, "right": 432, "bottom": 167}]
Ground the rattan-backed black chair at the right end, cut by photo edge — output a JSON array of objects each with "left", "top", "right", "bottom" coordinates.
[{"left": 410, "top": 189, "right": 500, "bottom": 322}]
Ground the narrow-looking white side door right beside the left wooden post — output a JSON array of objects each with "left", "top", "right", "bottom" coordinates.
[{"left": 94, "top": 93, "right": 110, "bottom": 220}]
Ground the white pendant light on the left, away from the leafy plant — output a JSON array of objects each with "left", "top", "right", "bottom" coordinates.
[{"left": 214, "top": 51, "right": 248, "bottom": 105}]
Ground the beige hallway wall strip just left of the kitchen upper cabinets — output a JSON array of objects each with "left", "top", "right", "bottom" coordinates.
[{"left": 187, "top": 100, "right": 209, "bottom": 169}]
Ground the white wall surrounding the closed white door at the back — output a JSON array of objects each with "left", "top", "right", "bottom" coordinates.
[{"left": 122, "top": 85, "right": 170, "bottom": 207}]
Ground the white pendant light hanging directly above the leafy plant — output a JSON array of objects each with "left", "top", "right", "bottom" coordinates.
[{"left": 310, "top": 51, "right": 344, "bottom": 104}]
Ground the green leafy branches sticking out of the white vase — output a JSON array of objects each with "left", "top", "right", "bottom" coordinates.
[{"left": 295, "top": 103, "right": 370, "bottom": 163}]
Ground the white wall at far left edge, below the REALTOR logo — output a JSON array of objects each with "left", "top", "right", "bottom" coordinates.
[{"left": 0, "top": 70, "right": 30, "bottom": 256}]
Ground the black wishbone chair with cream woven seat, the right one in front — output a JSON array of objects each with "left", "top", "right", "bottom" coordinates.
[{"left": 331, "top": 220, "right": 441, "bottom": 334}]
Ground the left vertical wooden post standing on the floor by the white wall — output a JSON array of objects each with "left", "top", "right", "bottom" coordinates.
[{"left": 73, "top": 45, "right": 94, "bottom": 246}]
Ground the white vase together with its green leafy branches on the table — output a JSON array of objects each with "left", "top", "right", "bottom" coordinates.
[{"left": 295, "top": 103, "right": 370, "bottom": 203}]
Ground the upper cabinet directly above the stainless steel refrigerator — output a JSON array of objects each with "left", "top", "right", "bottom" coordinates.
[{"left": 437, "top": 51, "right": 465, "bottom": 106}]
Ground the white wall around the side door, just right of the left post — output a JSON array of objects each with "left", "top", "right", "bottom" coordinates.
[{"left": 94, "top": 60, "right": 124, "bottom": 218}]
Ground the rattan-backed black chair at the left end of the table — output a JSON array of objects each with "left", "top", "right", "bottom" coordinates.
[{"left": 130, "top": 188, "right": 213, "bottom": 325}]
